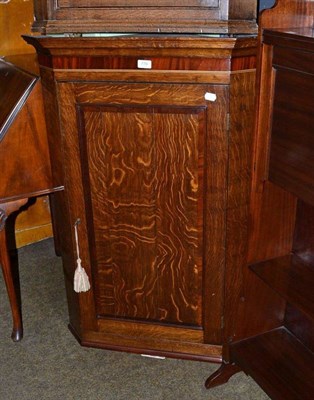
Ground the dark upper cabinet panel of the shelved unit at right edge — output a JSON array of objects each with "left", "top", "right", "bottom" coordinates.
[{"left": 264, "top": 29, "right": 314, "bottom": 204}]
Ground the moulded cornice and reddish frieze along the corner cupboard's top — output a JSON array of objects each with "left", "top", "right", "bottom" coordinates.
[{"left": 25, "top": 35, "right": 256, "bottom": 71}]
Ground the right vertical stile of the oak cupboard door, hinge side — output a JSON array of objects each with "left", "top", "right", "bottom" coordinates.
[{"left": 203, "top": 85, "right": 229, "bottom": 343}]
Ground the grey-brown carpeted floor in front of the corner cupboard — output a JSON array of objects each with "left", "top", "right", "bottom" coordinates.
[{"left": 0, "top": 239, "right": 268, "bottom": 400}]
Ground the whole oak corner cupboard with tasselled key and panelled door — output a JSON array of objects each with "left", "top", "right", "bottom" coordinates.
[{"left": 25, "top": 34, "right": 256, "bottom": 362}]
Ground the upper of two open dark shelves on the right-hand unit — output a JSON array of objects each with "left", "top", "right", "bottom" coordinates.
[{"left": 250, "top": 254, "right": 314, "bottom": 319}]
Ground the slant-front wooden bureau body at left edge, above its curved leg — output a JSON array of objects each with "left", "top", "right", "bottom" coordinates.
[{"left": 0, "top": 61, "right": 52, "bottom": 201}]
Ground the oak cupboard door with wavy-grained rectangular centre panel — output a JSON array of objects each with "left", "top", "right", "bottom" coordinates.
[{"left": 58, "top": 83, "right": 226, "bottom": 342}]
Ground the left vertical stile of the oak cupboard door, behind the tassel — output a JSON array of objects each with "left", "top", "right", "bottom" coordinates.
[{"left": 57, "top": 83, "right": 97, "bottom": 339}]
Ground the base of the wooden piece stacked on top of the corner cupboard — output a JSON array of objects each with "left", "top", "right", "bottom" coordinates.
[{"left": 33, "top": 0, "right": 257, "bottom": 34}]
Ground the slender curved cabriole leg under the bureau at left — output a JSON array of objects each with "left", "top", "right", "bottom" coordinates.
[{"left": 0, "top": 199, "right": 28, "bottom": 342}]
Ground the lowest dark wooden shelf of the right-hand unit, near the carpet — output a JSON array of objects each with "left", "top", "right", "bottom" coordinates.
[{"left": 230, "top": 328, "right": 314, "bottom": 400}]
